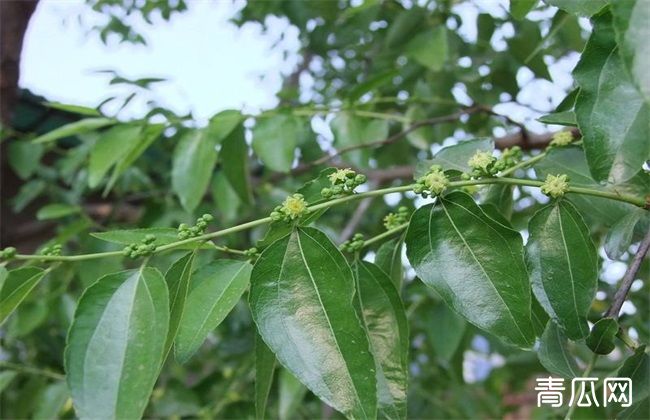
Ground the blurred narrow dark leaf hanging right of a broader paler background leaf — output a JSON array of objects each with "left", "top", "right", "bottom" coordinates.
[{"left": 219, "top": 124, "right": 253, "bottom": 204}]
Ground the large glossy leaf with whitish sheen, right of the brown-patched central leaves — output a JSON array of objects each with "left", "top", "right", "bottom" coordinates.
[{"left": 406, "top": 192, "right": 535, "bottom": 348}]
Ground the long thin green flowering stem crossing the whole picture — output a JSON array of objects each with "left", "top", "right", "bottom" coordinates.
[{"left": 7, "top": 178, "right": 646, "bottom": 261}]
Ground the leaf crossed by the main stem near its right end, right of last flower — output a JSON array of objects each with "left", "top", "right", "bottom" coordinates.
[{"left": 535, "top": 147, "right": 635, "bottom": 226}]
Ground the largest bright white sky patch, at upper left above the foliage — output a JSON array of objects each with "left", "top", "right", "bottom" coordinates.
[{"left": 20, "top": 0, "right": 299, "bottom": 118}]
